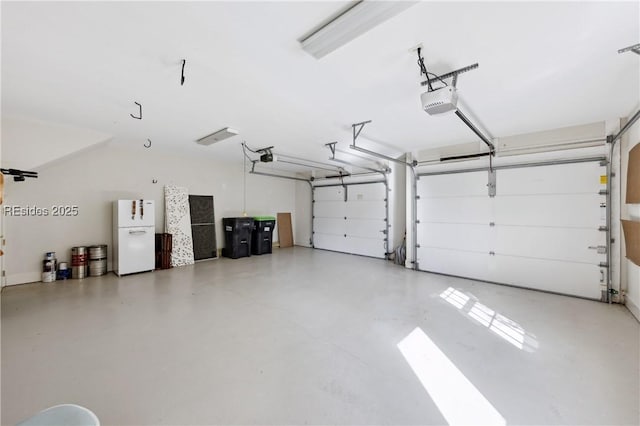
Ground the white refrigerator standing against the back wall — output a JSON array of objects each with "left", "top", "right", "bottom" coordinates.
[{"left": 113, "top": 200, "right": 156, "bottom": 275}]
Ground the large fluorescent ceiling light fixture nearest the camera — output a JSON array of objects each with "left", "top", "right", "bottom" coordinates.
[{"left": 298, "top": 0, "right": 417, "bottom": 59}]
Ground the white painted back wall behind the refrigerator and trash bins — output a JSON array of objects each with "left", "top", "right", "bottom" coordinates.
[{"left": 3, "top": 142, "right": 301, "bottom": 285}]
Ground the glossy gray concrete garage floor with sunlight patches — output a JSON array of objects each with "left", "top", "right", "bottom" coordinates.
[{"left": 1, "top": 247, "right": 640, "bottom": 425}]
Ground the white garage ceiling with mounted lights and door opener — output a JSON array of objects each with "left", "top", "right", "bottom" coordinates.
[{"left": 2, "top": 1, "right": 640, "bottom": 171}]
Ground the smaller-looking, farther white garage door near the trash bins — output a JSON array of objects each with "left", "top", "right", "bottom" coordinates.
[{"left": 313, "top": 183, "right": 387, "bottom": 258}]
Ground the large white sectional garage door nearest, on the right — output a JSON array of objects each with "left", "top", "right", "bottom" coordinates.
[{"left": 417, "top": 162, "right": 606, "bottom": 300}]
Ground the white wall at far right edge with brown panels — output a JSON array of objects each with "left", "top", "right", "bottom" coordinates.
[{"left": 620, "top": 106, "right": 640, "bottom": 321}]
